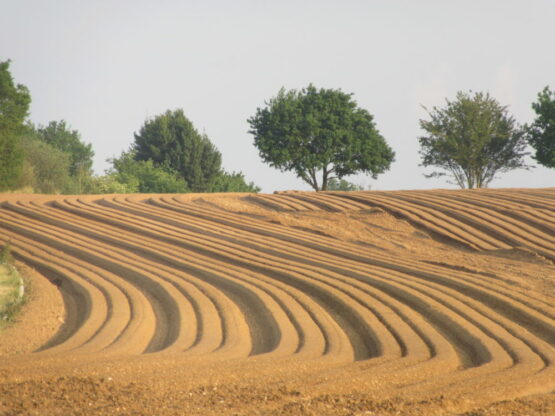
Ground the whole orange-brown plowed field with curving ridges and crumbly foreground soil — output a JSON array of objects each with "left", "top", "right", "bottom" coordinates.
[{"left": 0, "top": 188, "right": 555, "bottom": 415}]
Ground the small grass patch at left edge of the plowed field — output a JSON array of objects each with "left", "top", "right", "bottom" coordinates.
[{"left": 0, "top": 244, "right": 26, "bottom": 331}]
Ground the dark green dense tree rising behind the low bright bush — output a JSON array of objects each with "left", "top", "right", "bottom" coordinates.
[{"left": 133, "top": 110, "right": 221, "bottom": 192}]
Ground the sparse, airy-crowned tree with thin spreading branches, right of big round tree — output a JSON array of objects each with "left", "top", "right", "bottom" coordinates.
[{"left": 418, "top": 92, "right": 528, "bottom": 188}]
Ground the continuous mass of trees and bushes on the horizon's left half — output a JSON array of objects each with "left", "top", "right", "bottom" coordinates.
[{"left": 0, "top": 61, "right": 260, "bottom": 194}]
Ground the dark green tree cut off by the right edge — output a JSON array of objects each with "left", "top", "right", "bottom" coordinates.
[{"left": 528, "top": 87, "right": 555, "bottom": 168}]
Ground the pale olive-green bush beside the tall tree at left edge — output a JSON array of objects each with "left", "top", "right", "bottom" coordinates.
[{"left": 18, "top": 134, "right": 72, "bottom": 194}]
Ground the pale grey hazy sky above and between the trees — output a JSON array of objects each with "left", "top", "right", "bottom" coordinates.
[{"left": 0, "top": 0, "right": 555, "bottom": 192}]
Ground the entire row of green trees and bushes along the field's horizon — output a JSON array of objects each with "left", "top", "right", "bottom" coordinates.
[{"left": 0, "top": 61, "right": 555, "bottom": 193}]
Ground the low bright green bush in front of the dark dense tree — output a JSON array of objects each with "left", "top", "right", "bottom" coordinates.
[{"left": 111, "top": 151, "right": 189, "bottom": 193}]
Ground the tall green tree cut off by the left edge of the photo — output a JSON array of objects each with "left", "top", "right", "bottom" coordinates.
[{"left": 0, "top": 61, "right": 31, "bottom": 191}]
